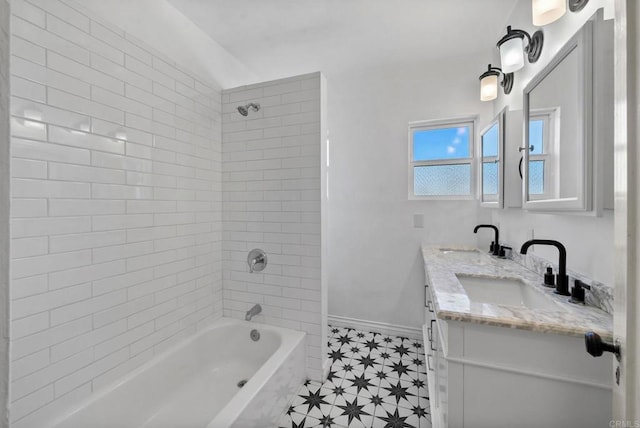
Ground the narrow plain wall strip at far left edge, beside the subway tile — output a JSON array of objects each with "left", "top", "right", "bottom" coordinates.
[{"left": 0, "top": 0, "right": 10, "bottom": 427}]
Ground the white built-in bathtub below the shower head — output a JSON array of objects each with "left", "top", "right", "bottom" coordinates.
[{"left": 53, "top": 318, "right": 305, "bottom": 428}]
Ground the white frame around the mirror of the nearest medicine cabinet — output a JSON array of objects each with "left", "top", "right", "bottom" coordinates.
[{"left": 522, "top": 20, "right": 594, "bottom": 211}]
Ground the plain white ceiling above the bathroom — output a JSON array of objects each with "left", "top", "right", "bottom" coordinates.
[{"left": 169, "top": 0, "right": 517, "bottom": 79}]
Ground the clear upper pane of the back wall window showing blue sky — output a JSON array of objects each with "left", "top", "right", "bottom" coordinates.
[{"left": 413, "top": 126, "right": 469, "bottom": 161}]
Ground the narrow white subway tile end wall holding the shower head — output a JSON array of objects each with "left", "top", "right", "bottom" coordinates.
[{"left": 222, "top": 73, "right": 326, "bottom": 381}]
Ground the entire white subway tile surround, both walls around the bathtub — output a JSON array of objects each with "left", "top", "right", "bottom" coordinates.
[{"left": 7, "top": 0, "right": 326, "bottom": 428}]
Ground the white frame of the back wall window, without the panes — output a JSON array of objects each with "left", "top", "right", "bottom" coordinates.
[{"left": 407, "top": 116, "right": 478, "bottom": 200}]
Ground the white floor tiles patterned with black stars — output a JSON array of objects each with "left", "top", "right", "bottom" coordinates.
[{"left": 278, "top": 326, "right": 431, "bottom": 428}]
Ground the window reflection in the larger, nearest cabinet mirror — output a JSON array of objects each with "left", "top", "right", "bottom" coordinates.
[{"left": 529, "top": 109, "right": 559, "bottom": 200}]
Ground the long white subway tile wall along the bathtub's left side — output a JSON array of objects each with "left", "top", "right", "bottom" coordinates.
[{"left": 9, "top": 0, "right": 225, "bottom": 428}]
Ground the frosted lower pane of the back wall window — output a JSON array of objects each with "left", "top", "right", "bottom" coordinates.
[{"left": 413, "top": 164, "right": 471, "bottom": 196}]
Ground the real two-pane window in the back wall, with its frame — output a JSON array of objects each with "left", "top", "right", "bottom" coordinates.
[{"left": 409, "top": 119, "right": 475, "bottom": 199}]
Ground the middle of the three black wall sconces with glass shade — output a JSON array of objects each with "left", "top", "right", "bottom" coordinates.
[{"left": 497, "top": 25, "right": 544, "bottom": 74}]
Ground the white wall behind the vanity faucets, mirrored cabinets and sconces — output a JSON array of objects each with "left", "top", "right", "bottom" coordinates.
[{"left": 490, "top": 0, "right": 613, "bottom": 285}]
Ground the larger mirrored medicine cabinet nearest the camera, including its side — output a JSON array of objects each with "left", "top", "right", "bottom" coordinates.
[{"left": 522, "top": 9, "right": 614, "bottom": 211}]
